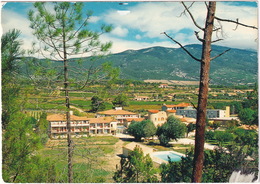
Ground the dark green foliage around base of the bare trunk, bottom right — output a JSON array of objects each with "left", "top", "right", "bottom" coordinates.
[{"left": 160, "top": 145, "right": 258, "bottom": 183}]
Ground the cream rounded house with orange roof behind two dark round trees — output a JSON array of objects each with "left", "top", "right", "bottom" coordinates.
[{"left": 148, "top": 110, "right": 168, "bottom": 127}]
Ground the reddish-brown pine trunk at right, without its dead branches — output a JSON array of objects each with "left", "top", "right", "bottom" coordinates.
[{"left": 192, "top": 2, "right": 216, "bottom": 183}]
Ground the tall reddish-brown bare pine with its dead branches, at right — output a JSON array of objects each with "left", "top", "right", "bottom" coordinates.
[{"left": 163, "top": 1, "right": 257, "bottom": 182}]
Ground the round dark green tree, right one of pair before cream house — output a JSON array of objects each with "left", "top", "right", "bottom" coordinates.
[{"left": 156, "top": 116, "right": 187, "bottom": 146}]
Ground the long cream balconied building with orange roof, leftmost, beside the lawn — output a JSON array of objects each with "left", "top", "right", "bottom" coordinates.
[{"left": 47, "top": 114, "right": 117, "bottom": 138}]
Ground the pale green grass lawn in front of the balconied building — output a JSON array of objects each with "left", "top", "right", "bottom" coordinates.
[{"left": 40, "top": 136, "right": 119, "bottom": 183}]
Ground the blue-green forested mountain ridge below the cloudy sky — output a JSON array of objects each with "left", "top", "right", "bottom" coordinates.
[{"left": 22, "top": 44, "right": 258, "bottom": 85}]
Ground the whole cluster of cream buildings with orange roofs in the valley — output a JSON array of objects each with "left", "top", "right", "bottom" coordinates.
[{"left": 47, "top": 103, "right": 238, "bottom": 138}]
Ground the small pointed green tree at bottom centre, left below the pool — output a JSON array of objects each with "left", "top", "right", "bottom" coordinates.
[{"left": 113, "top": 146, "right": 158, "bottom": 183}]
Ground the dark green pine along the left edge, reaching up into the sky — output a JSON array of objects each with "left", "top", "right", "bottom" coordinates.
[{"left": 1, "top": 29, "right": 23, "bottom": 129}]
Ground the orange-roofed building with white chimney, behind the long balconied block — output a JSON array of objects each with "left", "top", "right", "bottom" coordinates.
[{"left": 96, "top": 107, "right": 140, "bottom": 124}]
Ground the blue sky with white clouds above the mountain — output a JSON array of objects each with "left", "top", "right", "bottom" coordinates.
[{"left": 1, "top": 1, "right": 258, "bottom": 56}]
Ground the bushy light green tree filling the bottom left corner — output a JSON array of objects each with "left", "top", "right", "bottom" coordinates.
[{"left": 2, "top": 113, "right": 56, "bottom": 183}]
